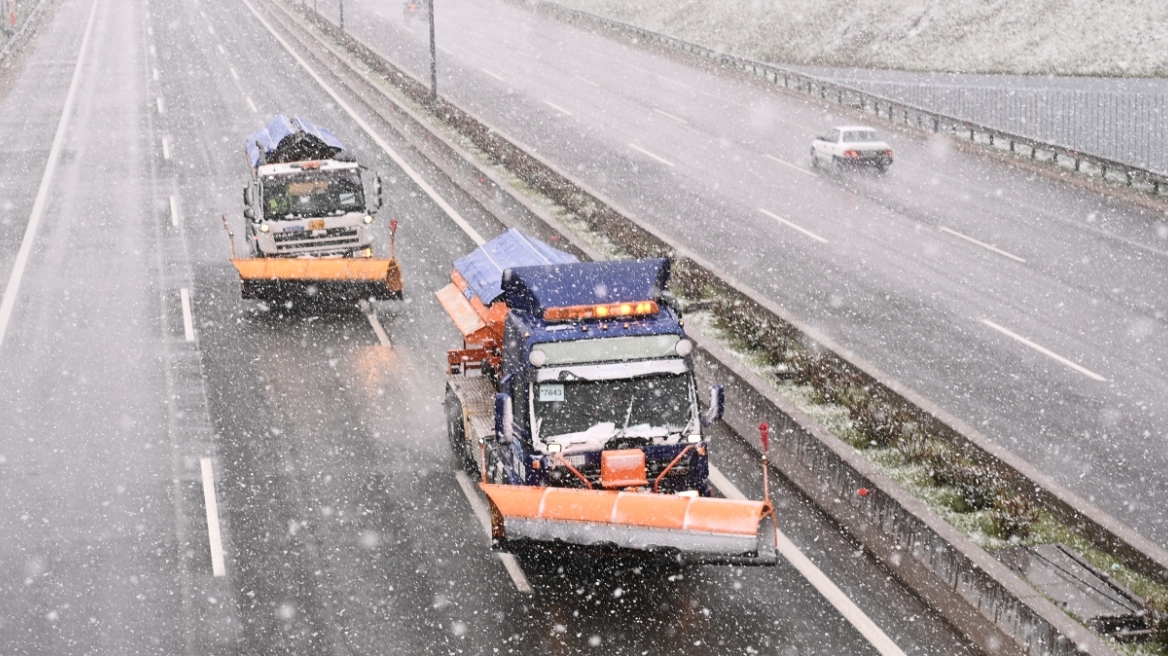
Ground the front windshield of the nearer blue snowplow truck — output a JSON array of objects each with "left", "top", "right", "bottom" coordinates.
[{"left": 533, "top": 372, "right": 694, "bottom": 440}]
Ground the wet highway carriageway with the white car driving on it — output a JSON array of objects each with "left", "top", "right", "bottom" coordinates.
[{"left": 320, "top": 0, "right": 1168, "bottom": 546}]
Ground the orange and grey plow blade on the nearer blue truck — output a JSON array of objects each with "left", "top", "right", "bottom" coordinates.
[{"left": 480, "top": 483, "right": 776, "bottom": 565}]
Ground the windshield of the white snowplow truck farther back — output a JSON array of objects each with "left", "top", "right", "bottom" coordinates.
[{"left": 264, "top": 170, "right": 364, "bottom": 221}]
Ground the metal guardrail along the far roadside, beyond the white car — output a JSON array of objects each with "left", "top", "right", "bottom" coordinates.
[{"left": 535, "top": 0, "right": 1168, "bottom": 196}]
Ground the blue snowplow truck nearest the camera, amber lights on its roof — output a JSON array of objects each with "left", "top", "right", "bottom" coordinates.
[{"left": 437, "top": 230, "right": 776, "bottom": 564}]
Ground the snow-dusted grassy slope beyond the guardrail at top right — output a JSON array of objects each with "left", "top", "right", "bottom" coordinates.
[{"left": 557, "top": 0, "right": 1168, "bottom": 77}]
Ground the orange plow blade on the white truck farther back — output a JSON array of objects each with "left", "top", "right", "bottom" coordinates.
[{"left": 231, "top": 258, "right": 402, "bottom": 300}]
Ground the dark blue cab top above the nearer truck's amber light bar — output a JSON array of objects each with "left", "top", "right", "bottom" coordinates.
[{"left": 503, "top": 258, "right": 669, "bottom": 315}]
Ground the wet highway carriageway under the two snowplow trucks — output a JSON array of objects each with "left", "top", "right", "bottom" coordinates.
[{"left": 0, "top": 0, "right": 973, "bottom": 656}]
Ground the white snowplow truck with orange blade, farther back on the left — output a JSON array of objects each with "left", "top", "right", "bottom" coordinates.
[{"left": 231, "top": 116, "right": 402, "bottom": 300}]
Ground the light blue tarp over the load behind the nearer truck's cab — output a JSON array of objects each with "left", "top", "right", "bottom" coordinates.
[{"left": 454, "top": 228, "right": 579, "bottom": 306}]
